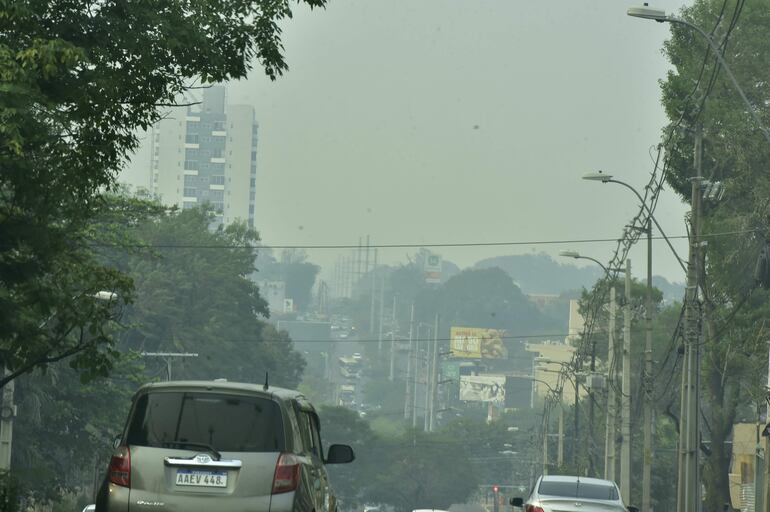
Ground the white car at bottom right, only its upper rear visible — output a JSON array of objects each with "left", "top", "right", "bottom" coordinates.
[{"left": 511, "top": 475, "right": 638, "bottom": 512}]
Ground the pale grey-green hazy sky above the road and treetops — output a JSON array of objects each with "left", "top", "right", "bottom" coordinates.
[{"left": 123, "top": 0, "right": 687, "bottom": 281}]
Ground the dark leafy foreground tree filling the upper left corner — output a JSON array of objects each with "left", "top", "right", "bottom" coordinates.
[{"left": 0, "top": 0, "right": 325, "bottom": 385}]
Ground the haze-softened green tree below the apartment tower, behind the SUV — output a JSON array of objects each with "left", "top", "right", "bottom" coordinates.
[{"left": 112, "top": 204, "right": 305, "bottom": 388}]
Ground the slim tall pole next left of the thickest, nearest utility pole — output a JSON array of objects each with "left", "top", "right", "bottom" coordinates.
[{"left": 642, "top": 216, "right": 653, "bottom": 512}]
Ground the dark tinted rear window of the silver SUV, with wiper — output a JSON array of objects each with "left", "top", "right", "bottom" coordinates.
[{"left": 127, "top": 391, "right": 285, "bottom": 452}]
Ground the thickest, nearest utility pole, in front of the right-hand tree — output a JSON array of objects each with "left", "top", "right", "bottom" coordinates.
[{"left": 677, "top": 126, "right": 703, "bottom": 512}]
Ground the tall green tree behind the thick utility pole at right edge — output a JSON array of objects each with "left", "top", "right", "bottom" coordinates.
[{"left": 662, "top": 0, "right": 770, "bottom": 511}]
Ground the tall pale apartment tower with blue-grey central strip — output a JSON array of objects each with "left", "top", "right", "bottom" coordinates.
[{"left": 150, "top": 86, "right": 258, "bottom": 227}]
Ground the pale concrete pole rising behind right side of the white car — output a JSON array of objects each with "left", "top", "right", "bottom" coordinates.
[{"left": 620, "top": 259, "right": 631, "bottom": 503}]
